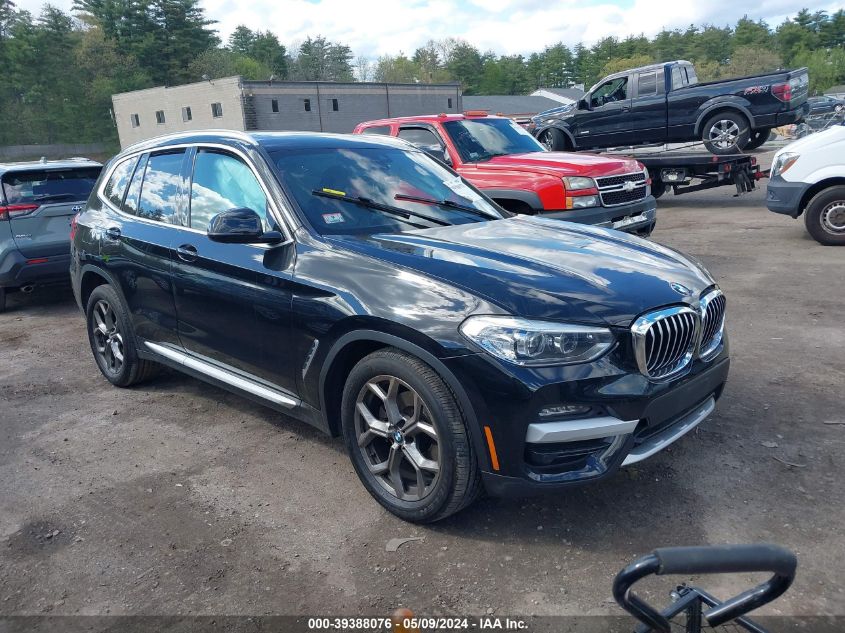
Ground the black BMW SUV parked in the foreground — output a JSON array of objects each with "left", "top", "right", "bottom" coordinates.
[{"left": 71, "top": 131, "right": 729, "bottom": 521}]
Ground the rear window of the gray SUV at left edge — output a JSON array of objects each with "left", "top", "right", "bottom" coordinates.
[{"left": 3, "top": 167, "right": 100, "bottom": 204}]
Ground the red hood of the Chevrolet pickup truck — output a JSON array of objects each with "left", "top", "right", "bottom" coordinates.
[{"left": 478, "top": 152, "right": 642, "bottom": 178}]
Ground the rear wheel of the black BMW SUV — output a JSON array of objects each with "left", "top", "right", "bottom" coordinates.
[{"left": 85, "top": 284, "right": 159, "bottom": 387}]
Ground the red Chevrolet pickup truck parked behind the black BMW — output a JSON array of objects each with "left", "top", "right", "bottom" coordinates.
[{"left": 354, "top": 112, "right": 657, "bottom": 235}]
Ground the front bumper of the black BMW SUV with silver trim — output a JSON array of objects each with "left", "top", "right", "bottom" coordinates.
[{"left": 451, "top": 338, "right": 730, "bottom": 496}]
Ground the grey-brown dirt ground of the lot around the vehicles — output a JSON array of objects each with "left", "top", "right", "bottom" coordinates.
[{"left": 0, "top": 154, "right": 845, "bottom": 616}]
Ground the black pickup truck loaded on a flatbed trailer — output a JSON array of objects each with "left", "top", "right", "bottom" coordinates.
[{"left": 529, "top": 60, "right": 809, "bottom": 154}]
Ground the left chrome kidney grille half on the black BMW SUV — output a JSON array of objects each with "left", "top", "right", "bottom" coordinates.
[{"left": 631, "top": 306, "right": 701, "bottom": 381}]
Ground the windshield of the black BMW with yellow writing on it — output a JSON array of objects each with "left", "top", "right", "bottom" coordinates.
[{"left": 270, "top": 147, "right": 503, "bottom": 235}]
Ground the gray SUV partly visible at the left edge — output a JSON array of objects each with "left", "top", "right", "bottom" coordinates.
[{"left": 0, "top": 158, "right": 102, "bottom": 312}]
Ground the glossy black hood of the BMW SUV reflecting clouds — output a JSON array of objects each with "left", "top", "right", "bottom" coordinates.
[{"left": 337, "top": 216, "right": 713, "bottom": 326}]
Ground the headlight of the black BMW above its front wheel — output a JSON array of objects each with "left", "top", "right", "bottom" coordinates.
[{"left": 460, "top": 316, "right": 616, "bottom": 366}]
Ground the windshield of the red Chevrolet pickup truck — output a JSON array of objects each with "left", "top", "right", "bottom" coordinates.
[{"left": 443, "top": 119, "right": 546, "bottom": 163}]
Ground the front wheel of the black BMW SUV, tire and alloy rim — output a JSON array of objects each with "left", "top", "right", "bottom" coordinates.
[{"left": 341, "top": 348, "right": 481, "bottom": 523}]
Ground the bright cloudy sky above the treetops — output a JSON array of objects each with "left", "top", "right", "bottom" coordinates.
[{"left": 14, "top": 0, "right": 845, "bottom": 58}]
